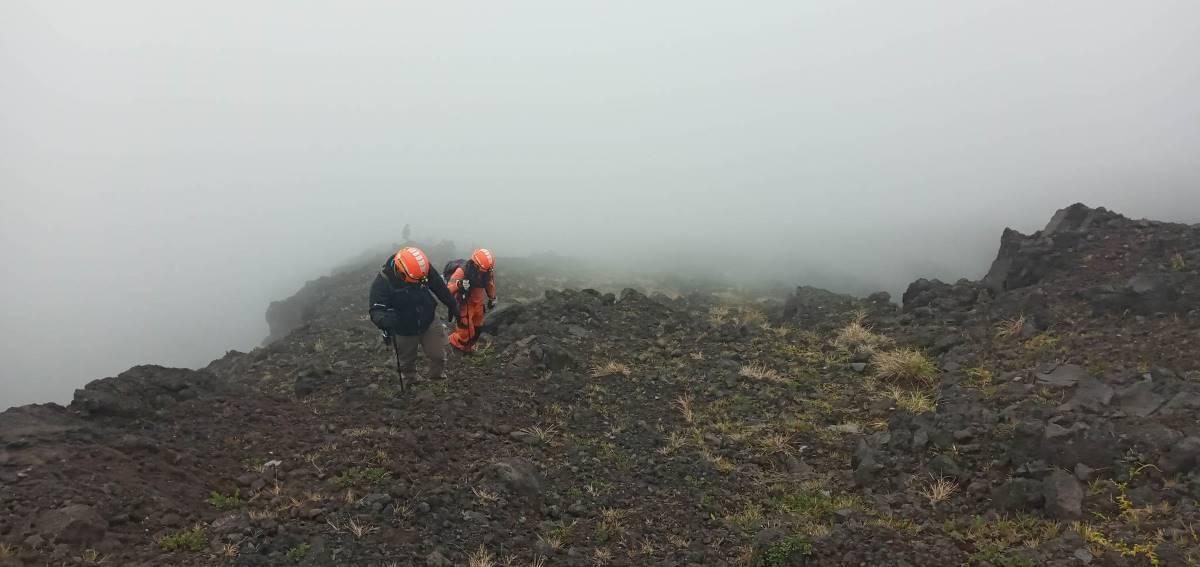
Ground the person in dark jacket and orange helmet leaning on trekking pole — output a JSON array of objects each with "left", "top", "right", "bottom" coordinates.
[{"left": 370, "top": 247, "right": 460, "bottom": 388}]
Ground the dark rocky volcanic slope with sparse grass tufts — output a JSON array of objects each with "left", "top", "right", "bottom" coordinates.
[{"left": 0, "top": 205, "right": 1200, "bottom": 567}]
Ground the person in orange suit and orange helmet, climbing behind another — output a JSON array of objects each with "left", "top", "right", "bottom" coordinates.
[{"left": 442, "top": 249, "right": 496, "bottom": 352}]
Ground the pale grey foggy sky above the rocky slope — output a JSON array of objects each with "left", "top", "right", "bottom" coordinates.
[{"left": 0, "top": 0, "right": 1200, "bottom": 407}]
